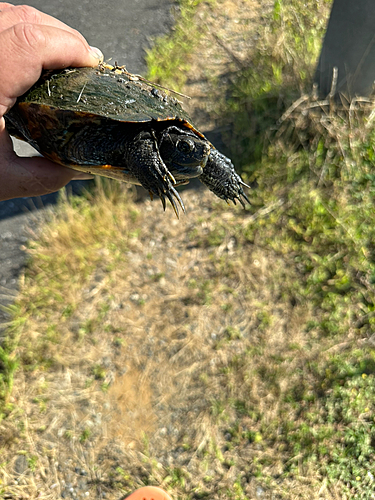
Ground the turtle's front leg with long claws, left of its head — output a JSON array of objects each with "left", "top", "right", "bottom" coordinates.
[{"left": 126, "top": 132, "right": 185, "bottom": 217}]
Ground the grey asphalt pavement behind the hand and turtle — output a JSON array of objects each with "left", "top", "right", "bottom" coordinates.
[{"left": 0, "top": 0, "right": 174, "bottom": 324}]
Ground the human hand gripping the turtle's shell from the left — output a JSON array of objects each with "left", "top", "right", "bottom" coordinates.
[{"left": 0, "top": 2, "right": 103, "bottom": 200}]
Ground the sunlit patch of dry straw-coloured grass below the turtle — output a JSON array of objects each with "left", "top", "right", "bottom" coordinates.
[{"left": 0, "top": 182, "right": 340, "bottom": 499}]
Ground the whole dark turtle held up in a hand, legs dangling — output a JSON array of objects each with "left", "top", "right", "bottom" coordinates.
[{"left": 5, "top": 64, "right": 249, "bottom": 217}]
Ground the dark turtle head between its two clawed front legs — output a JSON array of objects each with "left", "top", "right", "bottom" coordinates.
[{"left": 159, "top": 127, "right": 210, "bottom": 180}]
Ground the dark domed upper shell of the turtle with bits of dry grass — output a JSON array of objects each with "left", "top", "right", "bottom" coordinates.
[{"left": 11, "top": 65, "right": 204, "bottom": 138}]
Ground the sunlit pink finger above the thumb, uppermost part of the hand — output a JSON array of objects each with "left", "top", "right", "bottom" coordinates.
[{"left": 0, "top": 3, "right": 84, "bottom": 40}]
